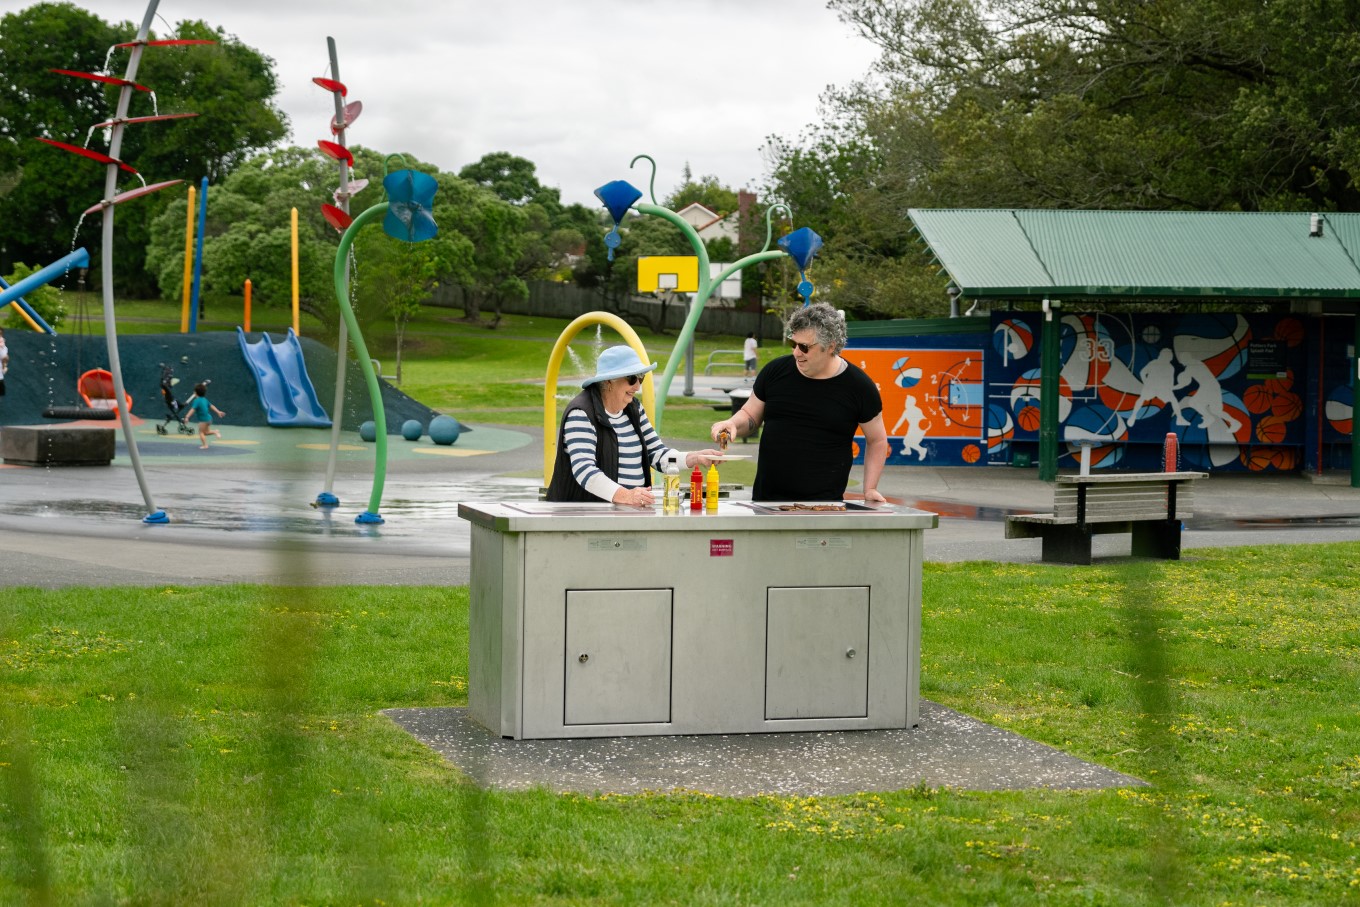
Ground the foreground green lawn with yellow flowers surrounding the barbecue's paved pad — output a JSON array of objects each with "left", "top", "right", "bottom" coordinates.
[{"left": 0, "top": 544, "right": 1360, "bottom": 907}]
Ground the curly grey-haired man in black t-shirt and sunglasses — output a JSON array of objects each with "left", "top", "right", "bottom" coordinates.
[{"left": 711, "top": 302, "right": 888, "bottom": 503}]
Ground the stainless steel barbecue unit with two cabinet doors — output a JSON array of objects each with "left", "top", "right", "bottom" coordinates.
[{"left": 458, "top": 502, "right": 938, "bottom": 738}]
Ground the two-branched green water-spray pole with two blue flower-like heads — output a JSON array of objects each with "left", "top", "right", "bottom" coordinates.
[{"left": 594, "top": 154, "right": 821, "bottom": 431}]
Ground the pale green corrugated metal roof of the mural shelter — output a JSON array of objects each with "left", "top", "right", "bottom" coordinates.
[{"left": 908, "top": 208, "right": 1360, "bottom": 301}]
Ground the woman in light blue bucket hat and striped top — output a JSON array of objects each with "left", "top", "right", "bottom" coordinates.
[{"left": 548, "top": 347, "right": 719, "bottom": 507}]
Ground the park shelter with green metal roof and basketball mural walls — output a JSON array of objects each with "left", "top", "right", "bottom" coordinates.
[{"left": 847, "top": 209, "right": 1360, "bottom": 484}]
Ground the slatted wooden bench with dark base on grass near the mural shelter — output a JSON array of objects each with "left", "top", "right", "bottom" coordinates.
[{"left": 1006, "top": 472, "right": 1209, "bottom": 564}]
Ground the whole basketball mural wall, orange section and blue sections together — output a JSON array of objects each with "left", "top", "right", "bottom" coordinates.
[{"left": 846, "top": 311, "right": 1332, "bottom": 470}]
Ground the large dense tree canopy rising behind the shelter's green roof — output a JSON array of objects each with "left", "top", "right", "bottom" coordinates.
[{"left": 767, "top": 0, "right": 1360, "bottom": 314}]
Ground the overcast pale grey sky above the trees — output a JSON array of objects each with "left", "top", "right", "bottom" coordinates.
[{"left": 37, "top": 0, "right": 876, "bottom": 205}]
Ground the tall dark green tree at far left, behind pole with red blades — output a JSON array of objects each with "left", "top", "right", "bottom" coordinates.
[{"left": 0, "top": 3, "right": 287, "bottom": 292}]
